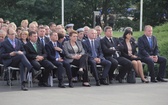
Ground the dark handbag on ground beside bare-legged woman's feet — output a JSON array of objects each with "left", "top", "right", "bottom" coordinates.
[{"left": 127, "top": 69, "right": 136, "bottom": 83}]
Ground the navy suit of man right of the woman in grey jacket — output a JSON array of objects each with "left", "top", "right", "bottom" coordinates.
[{"left": 83, "top": 39, "right": 111, "bottom": 81}]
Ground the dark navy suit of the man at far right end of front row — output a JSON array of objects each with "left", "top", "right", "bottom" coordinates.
[{"left": 138, "top": 35, "right": 167, "bottom": 80}]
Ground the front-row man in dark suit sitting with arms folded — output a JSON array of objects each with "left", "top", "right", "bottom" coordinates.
[{"left": 100, "top": 26, "right": 132, "bottom": 83}]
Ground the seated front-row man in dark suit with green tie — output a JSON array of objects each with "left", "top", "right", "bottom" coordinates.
[{"left": 24, "top": 31, "right": 55, "bottom": 87}]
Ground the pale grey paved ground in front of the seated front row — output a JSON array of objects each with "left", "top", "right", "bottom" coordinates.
[{"left": 0, "top": 79, "right": 168, "bottom": 105}]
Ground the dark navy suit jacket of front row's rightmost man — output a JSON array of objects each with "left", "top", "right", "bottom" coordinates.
[{"left": 138, "top": 35, "right": 158, "bottom": 57}]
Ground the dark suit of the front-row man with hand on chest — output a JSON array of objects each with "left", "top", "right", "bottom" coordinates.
[{"left": 45, "top": 41, "right": 72, "bottom": 80}]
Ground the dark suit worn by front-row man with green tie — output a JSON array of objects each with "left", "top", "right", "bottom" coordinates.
[{"left": 25, "top": 42, "right": 54, "bottom": 83}]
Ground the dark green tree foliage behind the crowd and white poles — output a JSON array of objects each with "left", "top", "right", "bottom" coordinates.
[{"left": 0, "top": 0, "right": 168, "bottom": 28}]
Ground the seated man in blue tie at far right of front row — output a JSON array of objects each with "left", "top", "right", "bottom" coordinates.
[{"left": 138, "top": 25, "right": 167, "bottom": 82}]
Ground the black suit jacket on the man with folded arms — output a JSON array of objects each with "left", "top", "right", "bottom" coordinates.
[{"left": 100, "top": 36, "right": 123, "bottom": 57}]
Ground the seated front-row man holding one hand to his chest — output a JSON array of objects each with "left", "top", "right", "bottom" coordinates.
[{"left": 45, "top": 32, "right": 73, "bottom": 88}]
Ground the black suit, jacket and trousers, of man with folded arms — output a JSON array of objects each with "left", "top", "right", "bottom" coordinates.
[{"left": 100, "top": 37, "right": 132, "bottom": 79}]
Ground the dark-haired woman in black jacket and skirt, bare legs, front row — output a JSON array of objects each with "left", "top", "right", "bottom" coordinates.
[{"left": 121, "top": 30, "right": 149, "bottom": 83}]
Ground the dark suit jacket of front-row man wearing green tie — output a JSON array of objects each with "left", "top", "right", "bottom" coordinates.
[{"left": 24, "top": 41, "right": 47, "bottom": 61}]
